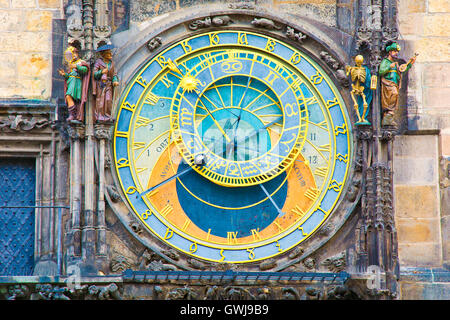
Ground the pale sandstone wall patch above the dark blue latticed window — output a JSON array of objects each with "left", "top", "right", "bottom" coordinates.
[{"left": 0, "top": 0, "right": 62, "bottom": 100}]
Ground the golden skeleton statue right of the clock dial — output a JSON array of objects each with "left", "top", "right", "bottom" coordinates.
[{"left": 345, "top": 55, "right": 372, "bottom": 125}]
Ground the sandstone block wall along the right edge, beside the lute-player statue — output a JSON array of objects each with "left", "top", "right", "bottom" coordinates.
[{"left": 394, "top": 0, "right": 450, "bottom": 267}]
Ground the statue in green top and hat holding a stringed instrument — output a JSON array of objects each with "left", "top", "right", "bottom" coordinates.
[{"left": 378, "top": 42, "right": 418, "bottom": 126}]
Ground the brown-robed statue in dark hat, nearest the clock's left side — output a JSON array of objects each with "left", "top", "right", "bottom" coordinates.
[{"left": 92, "top": 44, "right": 119, "bottom": 122}]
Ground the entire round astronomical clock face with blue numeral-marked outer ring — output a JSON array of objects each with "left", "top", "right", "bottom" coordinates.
[{"left": 113, "top": 30, "right": 352, "bottom": 263}]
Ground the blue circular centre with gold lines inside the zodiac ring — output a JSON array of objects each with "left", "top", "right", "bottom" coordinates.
[{"left": 195, "top": 76, "right": 283, "bottom": 161}]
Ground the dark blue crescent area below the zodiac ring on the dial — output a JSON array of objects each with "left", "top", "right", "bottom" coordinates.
[{"left": 176, "top": 164, "right": 287, "bottom": 238}]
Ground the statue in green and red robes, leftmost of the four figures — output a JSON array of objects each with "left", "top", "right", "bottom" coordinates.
[{"left": 58, "top": 44, "right": 90, "bottom": 123}]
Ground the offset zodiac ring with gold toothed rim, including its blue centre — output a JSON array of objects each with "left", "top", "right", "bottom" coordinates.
[{"left": 170, "top": 48, "right": 308, "bottom": 187}]
